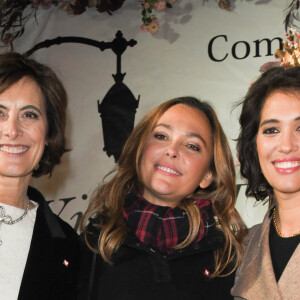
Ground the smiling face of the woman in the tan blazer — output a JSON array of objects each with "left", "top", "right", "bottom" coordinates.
[{"left": 256, "top": 91, "right": 300, "bottom": 199}]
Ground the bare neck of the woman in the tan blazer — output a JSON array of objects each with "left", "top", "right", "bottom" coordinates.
[{"left": 275, "top": 194, "right": 300, "bottom": 237}]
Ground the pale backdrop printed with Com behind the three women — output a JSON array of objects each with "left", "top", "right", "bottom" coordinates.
[{"left": 3, "top": 0, "right": 290, "bottom": 228}]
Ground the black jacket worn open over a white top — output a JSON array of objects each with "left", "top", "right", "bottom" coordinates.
[{"left": 18, "top": 187, "right": 82, "bottom": 300}]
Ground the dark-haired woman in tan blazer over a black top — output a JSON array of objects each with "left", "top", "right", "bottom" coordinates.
[{"left": 232, "top": 67, "right": 300, "bottom": 300}]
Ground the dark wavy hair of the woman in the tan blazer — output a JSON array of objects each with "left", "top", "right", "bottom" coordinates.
[{"left": 237, "top": 67, "right": 300, "bottom": 205}]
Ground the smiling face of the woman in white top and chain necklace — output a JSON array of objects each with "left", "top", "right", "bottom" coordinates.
[{"left": 0, "top": 77, "right": 47, "bottom": 177}]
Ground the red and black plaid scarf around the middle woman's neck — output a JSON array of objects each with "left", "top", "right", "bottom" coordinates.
[{"left": 123, "top": 193, "right": 215, "bottom": 254}]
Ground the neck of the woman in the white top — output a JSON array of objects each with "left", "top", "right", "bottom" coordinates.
[{"left": 0, "top": 177, "right": 30, "bottom": 208}]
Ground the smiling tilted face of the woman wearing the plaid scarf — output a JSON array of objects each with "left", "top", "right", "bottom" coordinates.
[{"left": 140, "top": 104, "right": 213, "bottom": 207}]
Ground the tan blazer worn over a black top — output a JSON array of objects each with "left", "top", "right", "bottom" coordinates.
[{"left": 231, "top": 212, "right": 300, "bottom": 300}]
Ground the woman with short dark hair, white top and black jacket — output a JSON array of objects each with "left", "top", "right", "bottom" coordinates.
[{"left": 0, "top": 53, "right": 80, "bottom": 300}]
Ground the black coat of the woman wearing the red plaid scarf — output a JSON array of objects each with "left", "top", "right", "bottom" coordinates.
[{"left": 82, "top": 220, "right": 234, "bottom": 300}]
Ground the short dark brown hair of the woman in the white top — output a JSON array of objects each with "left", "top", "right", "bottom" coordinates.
[{"left": 0, "top": 52, "right": 67, "bottom": 177}]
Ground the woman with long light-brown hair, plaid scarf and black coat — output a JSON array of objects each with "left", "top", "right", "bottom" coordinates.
[{"left": 82, "top": 97, "right": 245, "bottom": 300}]
